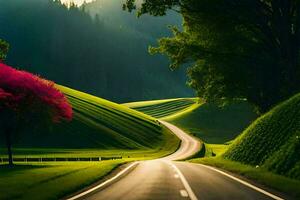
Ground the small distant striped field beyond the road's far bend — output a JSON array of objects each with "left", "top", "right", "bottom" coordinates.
[{"left": 124, "top": 98, "right": 199, "bottom": 118}]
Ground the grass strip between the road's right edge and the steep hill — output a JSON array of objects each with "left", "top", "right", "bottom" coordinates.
[{"left": 189, "top": 157, "right": 300, "bottom": 199}]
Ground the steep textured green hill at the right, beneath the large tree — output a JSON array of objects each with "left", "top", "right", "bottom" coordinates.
[{"left": 223, "top": 94, "right": 300, "bottom": 180}]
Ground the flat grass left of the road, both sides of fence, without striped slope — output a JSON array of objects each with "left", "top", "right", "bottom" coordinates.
[{"left": 0, "top": 123, "right": 180, "bottom": 200}]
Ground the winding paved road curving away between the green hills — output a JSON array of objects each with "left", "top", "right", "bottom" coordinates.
[{"left": 69, "top": 121, "right": 281, "bottom": 200}]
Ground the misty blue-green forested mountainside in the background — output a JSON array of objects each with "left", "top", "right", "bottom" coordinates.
[{"left": 0, "top": 0, "right": 193, "bottom": 102}]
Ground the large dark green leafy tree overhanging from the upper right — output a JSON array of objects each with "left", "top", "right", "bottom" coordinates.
[{"left": 124, "top": 0, "right": 300, "bottom": 112}]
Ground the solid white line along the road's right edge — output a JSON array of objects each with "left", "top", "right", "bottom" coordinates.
[{"left": 197, "top": 164, "right": 284, "bottom": 200}]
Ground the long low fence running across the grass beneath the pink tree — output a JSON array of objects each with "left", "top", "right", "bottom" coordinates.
[{"left": 0, "top": 156, "right": 122, "bottom": 163}]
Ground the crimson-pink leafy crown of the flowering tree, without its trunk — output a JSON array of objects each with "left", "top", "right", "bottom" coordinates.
[{"left": 0, "top": 63, "right": 72, "bottom": 123}]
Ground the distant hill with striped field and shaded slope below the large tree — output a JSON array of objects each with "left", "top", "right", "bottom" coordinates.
[{"left": 125, "top": 98, "right": 257, "bottom": 143}]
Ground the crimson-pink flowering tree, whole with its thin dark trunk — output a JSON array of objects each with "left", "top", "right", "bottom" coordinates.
[{"left": 0, "top": 63, "right": 72, "bottom": 166}]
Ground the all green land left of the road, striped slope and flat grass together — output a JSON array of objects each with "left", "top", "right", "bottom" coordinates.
[{"left": 0, "top": 86, "right": 180, "bottom": 200}]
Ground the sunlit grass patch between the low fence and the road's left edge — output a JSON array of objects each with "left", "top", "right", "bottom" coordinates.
[{"left": 0, "top": 161, "right": 124, "bottom": 200}]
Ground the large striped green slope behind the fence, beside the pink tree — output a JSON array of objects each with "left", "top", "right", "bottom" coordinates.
[{"left": 2, "top": 86, "right": 177, "bottom": 149}]
